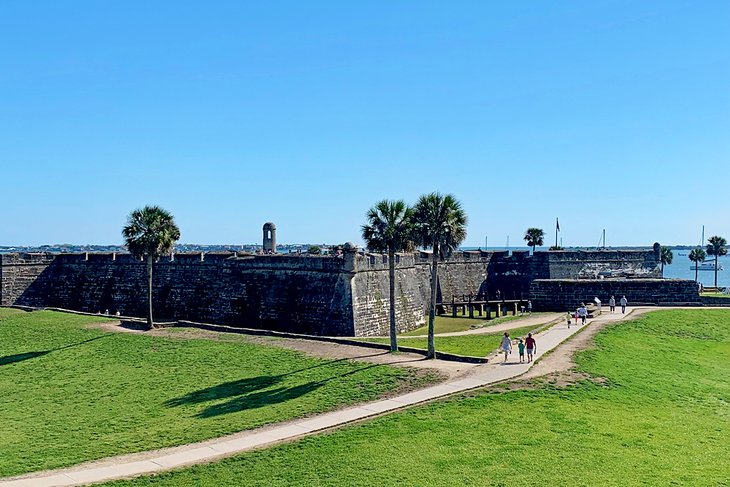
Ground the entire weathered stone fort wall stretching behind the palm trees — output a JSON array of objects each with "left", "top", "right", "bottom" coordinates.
[{"left": 0, "top": 249, "right": 699, "bottom": 336}]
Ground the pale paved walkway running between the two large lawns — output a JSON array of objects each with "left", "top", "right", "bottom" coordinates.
[{"left": 0, "top": 310, "right": 631, "bottom": 487}]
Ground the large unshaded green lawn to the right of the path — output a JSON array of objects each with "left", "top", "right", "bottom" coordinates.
[{"left": 108, "top": 310, "right": 730, "bottom": 487}]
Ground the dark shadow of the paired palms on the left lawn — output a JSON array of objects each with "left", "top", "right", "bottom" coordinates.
[{"left": 165, "top": 359, "right": 378, "bottom": 418}]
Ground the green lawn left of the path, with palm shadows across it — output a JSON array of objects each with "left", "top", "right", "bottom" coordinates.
[{"left": 0, "top": 308, "right": 436, "bottom": 477}]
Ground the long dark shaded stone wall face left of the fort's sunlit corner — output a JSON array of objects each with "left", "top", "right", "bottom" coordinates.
[{"left": 0, "top": 253, "right": 355, "bottom": 335}]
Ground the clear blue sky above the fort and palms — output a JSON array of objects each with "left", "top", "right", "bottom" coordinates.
[{"left": 0, "top": 0, "right": 730, "bottom": 246}]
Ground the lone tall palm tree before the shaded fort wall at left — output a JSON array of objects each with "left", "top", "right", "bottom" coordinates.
[{"left": 122, "top": 206, "right": 180, "bottom": 329}]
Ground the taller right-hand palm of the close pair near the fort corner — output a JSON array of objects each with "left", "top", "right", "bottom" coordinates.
[{"left": 413, "top": 193, "right": 467, "bottom": 358}]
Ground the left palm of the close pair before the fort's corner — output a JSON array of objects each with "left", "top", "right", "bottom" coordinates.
[{"left": 362, "top": 200, "right": 413, "bottom": 352}]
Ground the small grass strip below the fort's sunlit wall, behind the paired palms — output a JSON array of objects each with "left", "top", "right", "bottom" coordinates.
[{"left": 357, "top": 325, "right": 540, "bottom": 357}]
